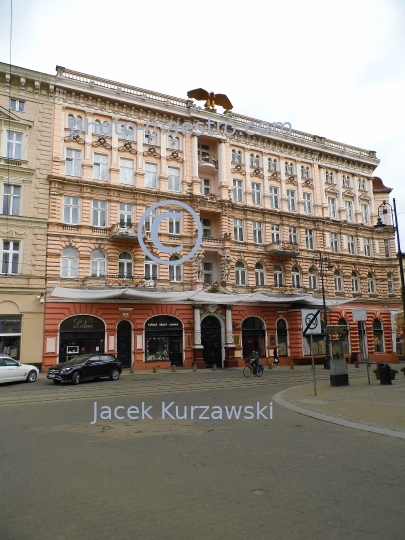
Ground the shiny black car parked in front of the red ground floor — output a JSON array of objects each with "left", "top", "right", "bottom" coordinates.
[{"left": 46, "top": 354, "right": 122, "bottom": 384}]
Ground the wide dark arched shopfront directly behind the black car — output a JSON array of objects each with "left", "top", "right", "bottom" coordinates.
[{"left": 59, "top": 315, "right": 105, "bottom": 362}]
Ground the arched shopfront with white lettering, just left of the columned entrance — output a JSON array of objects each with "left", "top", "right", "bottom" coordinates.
[{"left": 145, "top": 315, "right": 183, "bottom": 366}]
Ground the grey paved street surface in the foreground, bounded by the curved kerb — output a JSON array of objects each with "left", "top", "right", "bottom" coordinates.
[{"left": 0, "top": 370, "right": 404, "bottom": 540}]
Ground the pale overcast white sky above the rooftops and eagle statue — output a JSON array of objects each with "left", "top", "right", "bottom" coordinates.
[{"left": 0, "top": 0, "right": 405, "bottom": 245}]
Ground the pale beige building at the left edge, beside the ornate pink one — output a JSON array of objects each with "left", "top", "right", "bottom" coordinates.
[{"left": 0, "top": 63, "right": 55, "bottom": 366}]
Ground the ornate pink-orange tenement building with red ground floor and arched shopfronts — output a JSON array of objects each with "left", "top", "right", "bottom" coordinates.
[{"left": 34, "top": 67, "right": 399, "bottom": 369}]
